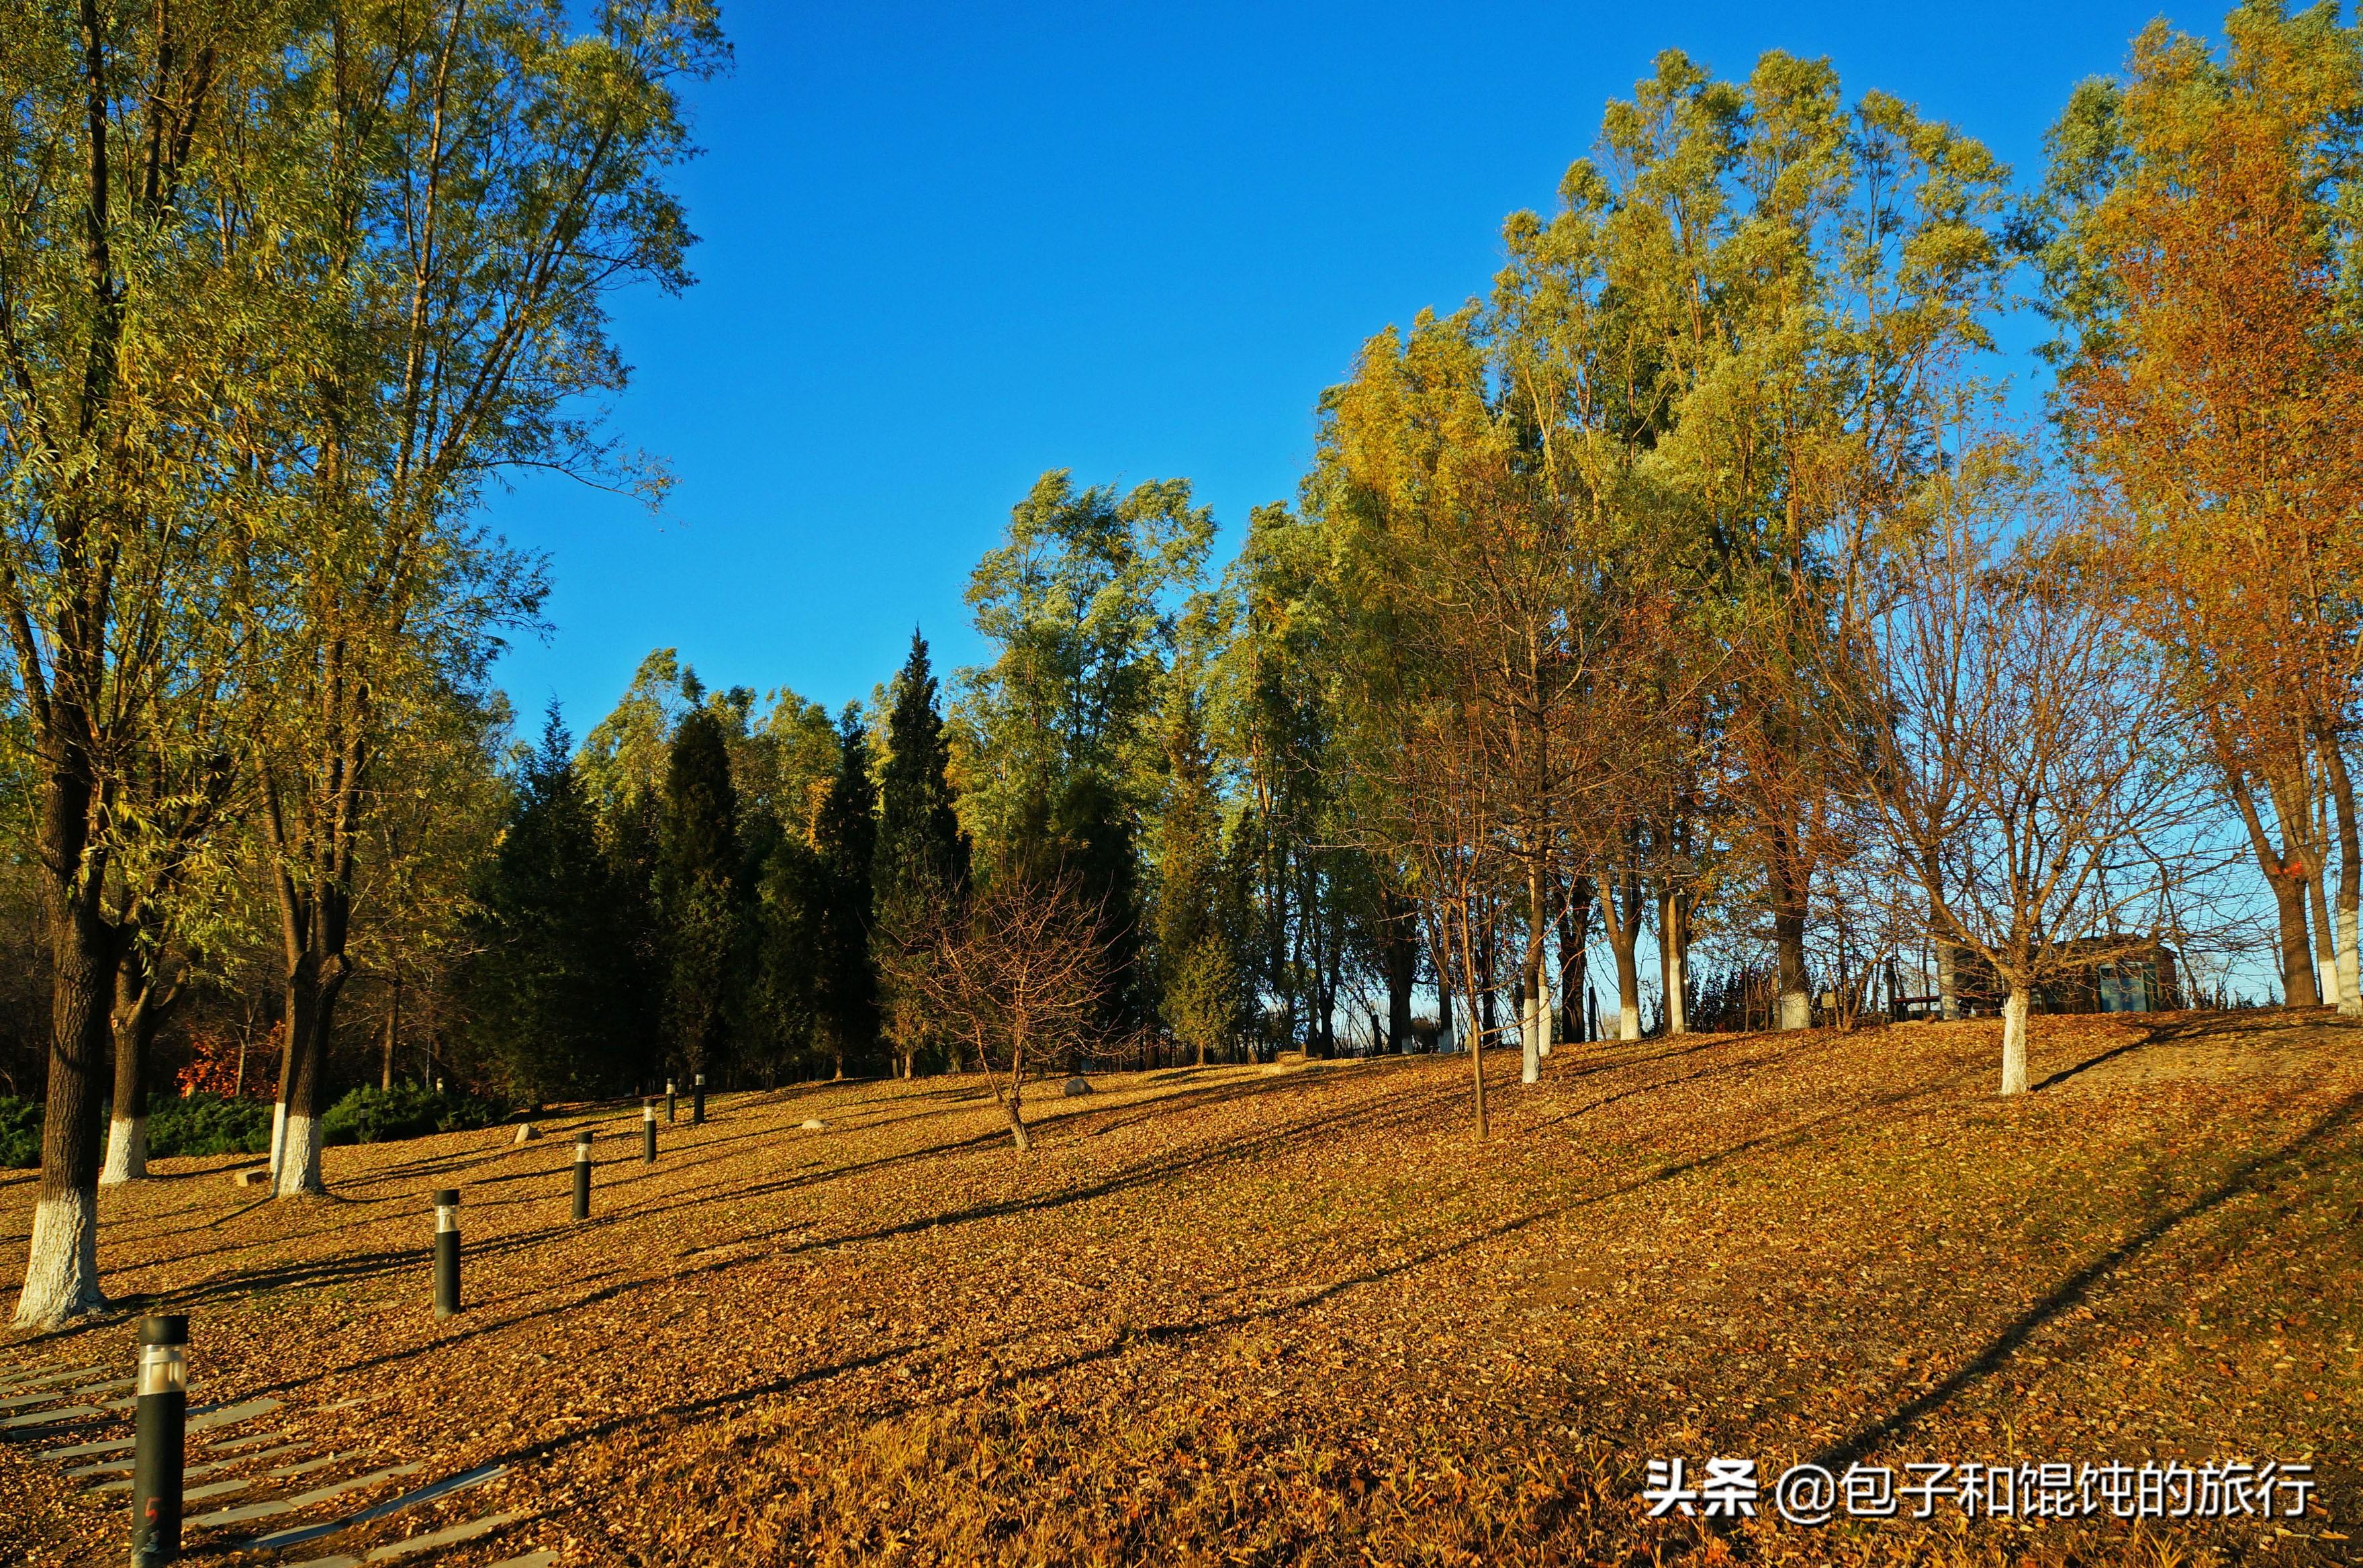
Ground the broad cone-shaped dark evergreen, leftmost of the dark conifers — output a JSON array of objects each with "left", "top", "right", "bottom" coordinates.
[{"left": 468, "top": 704, "right": 638, "bottom": 1103}]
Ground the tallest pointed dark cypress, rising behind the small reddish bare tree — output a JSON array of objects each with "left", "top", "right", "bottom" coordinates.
[{"left": 874, "top": 631, "right": 969, "bottom": 1074}]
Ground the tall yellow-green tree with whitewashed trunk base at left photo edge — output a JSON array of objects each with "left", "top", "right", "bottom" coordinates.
[{"left": 0, "top": 0, "right": 293, "bottom": 1327}]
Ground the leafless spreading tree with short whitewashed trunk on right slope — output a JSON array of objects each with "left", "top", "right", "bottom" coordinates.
[{"left": 1853, "top": 451, "right": 2223, "bottom": 1093}]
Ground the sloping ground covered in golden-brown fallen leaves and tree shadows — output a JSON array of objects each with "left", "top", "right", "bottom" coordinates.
[{"left": 0, "top": 1015, "right": 2363, "bottom": 1565}]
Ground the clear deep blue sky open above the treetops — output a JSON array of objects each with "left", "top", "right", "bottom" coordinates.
[{"left": 492, "top": 0, "right": 2192, "bottom": 737}]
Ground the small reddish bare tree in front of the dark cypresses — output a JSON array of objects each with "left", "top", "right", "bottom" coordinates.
[{"left": 886, "top": 876, "right": 1108, "bottom": 1152}]
